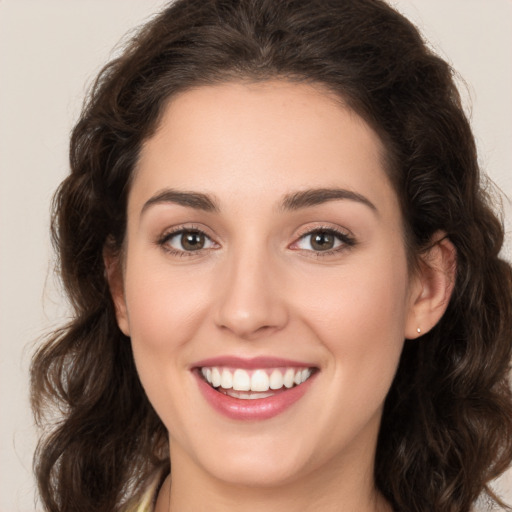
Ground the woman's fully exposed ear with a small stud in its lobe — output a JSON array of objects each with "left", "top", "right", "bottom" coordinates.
[{"left": 405, "top": 232, "right": 457, "bottom": 339}]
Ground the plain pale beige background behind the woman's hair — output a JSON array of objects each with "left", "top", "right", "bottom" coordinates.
[{"left": 0, "top": 0, "right": 512, "bottom": 512}]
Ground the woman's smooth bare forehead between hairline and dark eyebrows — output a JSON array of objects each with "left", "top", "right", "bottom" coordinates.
[{"left": 132, "top": 81, "right": 394, "bottom": 218}]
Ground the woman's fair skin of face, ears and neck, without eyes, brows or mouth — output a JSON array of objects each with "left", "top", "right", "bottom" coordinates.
[{"left": 106, "top": 81, "right": 454, "bottom": 512}]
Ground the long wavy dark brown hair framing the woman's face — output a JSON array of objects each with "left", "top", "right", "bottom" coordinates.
[{"left": 31, "top": 0, "right": 512, "bottom": 512}]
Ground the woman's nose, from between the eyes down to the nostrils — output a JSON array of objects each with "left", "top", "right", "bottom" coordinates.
[{"left": 215, "top": 245, "right": 288, "bottom": 340}]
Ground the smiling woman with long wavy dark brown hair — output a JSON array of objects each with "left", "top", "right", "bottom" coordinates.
[{"left": 32, "top": 0, "right": 512, "bottom": 512}]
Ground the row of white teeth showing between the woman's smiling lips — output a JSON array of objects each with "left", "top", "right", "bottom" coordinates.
[{"left": 201, "top": 367, "right": 312, "bottom": 392}]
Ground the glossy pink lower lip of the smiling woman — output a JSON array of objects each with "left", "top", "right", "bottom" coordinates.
[{"left": 195, "top": 372, "right": 316, "bottom": 421}]
